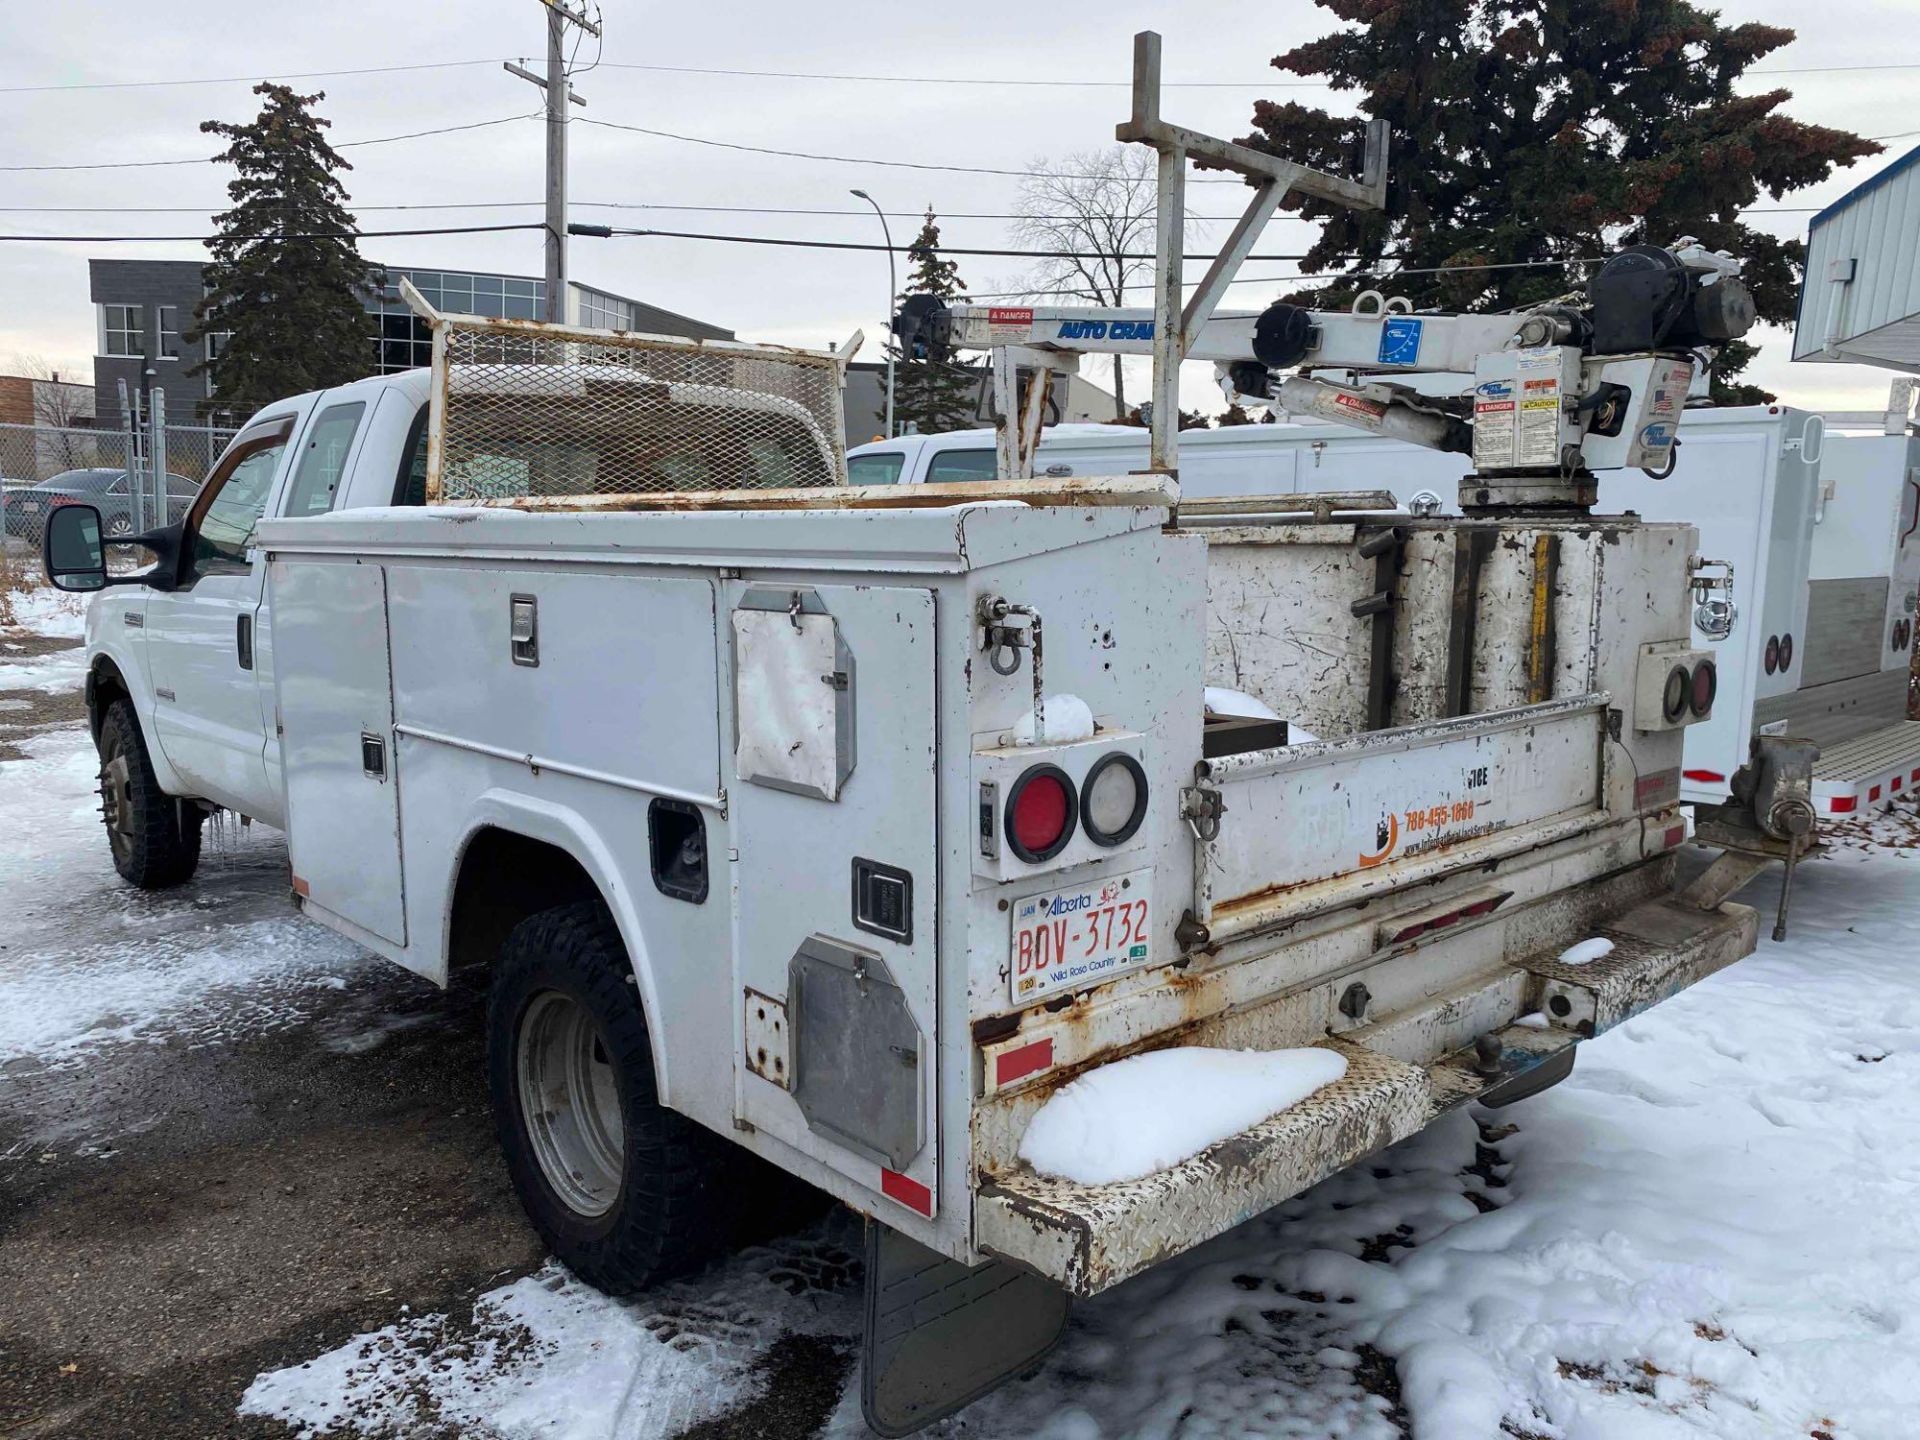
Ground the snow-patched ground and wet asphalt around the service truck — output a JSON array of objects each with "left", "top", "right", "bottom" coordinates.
[{"left": 0, "top": 587, "right": 1920, "bottom": 1440}]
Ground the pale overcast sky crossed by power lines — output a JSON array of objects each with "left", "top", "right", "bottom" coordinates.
[{"left": 0, "top": 0, "right": 1920, "bottom": 420}]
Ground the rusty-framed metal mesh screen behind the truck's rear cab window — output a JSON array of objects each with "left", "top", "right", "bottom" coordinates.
[{"left": 441, "top": 321, "right": 847, "bottom": 503}]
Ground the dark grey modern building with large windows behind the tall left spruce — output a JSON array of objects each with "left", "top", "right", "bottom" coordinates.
[{"left": 86, "top": 259, "right": 733, "bottom": 428}]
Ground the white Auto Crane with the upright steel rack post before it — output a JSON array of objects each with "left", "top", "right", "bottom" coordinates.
[{"left": 895, "top": 31, "right": 1755, "bottom": 515}]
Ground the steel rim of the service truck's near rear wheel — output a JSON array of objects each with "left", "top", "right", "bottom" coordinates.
[{"left": 515, "top": 991, "right": 626, "bottom": 1217}]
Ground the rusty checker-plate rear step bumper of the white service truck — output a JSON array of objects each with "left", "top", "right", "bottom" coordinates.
[{"left": 973, "top": 899, "right": 1759, "bottom": 1296}]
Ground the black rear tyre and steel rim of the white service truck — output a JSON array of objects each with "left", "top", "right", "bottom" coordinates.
[{"left": 488, "top": 900, "right": 751, "bottom": 1294}]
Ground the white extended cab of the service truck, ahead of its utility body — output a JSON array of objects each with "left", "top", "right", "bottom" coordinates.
[{"left": 86, "top": 371, "right": 426, "bottom": 844}]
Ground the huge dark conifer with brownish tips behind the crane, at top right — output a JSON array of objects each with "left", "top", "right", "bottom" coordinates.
[{"left": 1242, "top": 0, "right": 1880, "bottom": 403}]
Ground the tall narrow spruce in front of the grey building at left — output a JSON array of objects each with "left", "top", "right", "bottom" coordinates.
[{"left": 184, "top": 83, "right": 380, "bottom": 417}]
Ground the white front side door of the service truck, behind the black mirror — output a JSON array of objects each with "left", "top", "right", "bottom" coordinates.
[{"left": 144, "top": 411, "right": 300, "bottom": 826}]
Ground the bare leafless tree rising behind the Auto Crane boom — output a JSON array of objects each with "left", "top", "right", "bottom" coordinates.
[{"left": 1012, "top": 146, "right": 1154, "bottom": 420}]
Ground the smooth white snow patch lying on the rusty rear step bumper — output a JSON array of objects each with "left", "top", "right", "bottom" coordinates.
[{"left": 1020, "top": 1044, "right": 1346, "bottom": 1185}]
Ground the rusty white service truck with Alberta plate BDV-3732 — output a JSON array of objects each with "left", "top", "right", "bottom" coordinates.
[{"left": 46, "top": 36, "right": 1812, "bottom": 1434}]
